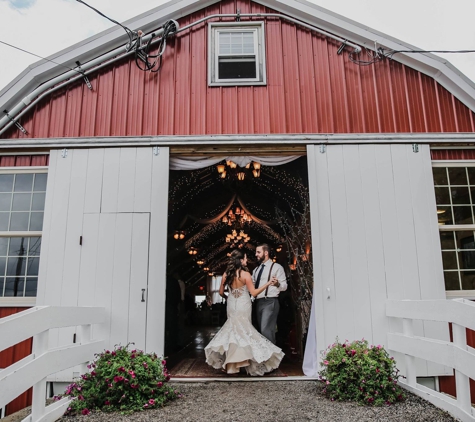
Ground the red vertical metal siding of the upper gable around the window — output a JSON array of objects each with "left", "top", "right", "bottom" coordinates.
[{"left": 1, "top": 0, "right": 474, "bottom": 138}]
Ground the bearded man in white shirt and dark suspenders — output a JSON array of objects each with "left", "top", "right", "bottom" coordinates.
[{"left": 252, "top": 243, "right": 287, "bottom": 344}]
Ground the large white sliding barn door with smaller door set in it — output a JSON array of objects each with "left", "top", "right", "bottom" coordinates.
[{"left": 37, "top": 147, "right": 168, "bottom": 380}]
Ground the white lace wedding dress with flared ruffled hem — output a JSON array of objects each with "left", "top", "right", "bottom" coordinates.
[{"left": 205, "top": 285, "right": 284, "bottom": 375}]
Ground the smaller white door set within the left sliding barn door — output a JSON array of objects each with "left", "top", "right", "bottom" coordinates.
[{"left": 79, "top": 213, "right": 150, "bottom": 350}]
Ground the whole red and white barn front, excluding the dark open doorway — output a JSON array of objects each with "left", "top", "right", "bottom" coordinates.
[{"left": 0, "top": 0, "right": 475, "bottom": 418}]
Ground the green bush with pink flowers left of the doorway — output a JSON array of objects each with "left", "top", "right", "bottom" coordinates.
[{"left": 56, "top": 345, "right": 181, "bottom": 415}]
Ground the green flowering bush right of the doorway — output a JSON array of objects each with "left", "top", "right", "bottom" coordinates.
[{"left": 319, "top": 338, "right": 405, "bottom": 406}]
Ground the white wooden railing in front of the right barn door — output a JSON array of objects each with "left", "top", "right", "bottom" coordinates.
[{"left": 386, "top": 299, "right": 475, "bottom": 421}]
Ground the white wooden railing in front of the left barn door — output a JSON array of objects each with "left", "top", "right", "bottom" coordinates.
[{"left": 0, "top": 306, "right": 105, "bottom": 422}]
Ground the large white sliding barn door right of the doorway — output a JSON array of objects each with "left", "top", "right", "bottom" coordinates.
[{"left": 308, "top": 145, "right": 448, "bottom": 376}]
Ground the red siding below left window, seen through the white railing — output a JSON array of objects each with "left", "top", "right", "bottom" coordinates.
[{"left": 0, "top": 308, "right": 32, "bottom": 415}]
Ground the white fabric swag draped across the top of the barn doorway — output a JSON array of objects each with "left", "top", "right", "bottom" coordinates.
[{"left": 170, "top": 155, "right": 300, "bottom": 170}]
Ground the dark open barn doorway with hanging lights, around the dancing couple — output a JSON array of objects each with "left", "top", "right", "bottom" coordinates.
[{"left": 165, "top": 154, "right": 313, "bottom": 378}]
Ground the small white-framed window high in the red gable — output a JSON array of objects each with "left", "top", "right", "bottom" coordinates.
[{"left": 208, "top": 22, "right": 266, "bottom": 86}]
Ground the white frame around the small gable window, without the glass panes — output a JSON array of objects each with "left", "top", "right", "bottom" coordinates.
[{"left": 208, "top": 22, "right": 267, "bottom": 86}]
